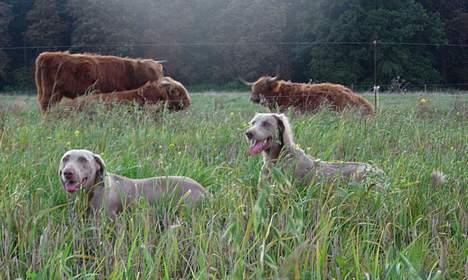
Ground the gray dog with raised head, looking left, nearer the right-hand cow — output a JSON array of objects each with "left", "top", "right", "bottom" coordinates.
[{"left": 245, "top": 113, "right": 383, "bottom": 184}]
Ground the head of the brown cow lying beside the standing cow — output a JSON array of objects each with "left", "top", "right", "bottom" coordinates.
[{"left": 158, "top": 77, "right": 192, "bottom": 111}]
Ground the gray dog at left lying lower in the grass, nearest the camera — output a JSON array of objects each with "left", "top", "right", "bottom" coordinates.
[{"left": 59, "top": 150, "right": 206, "bottom": 218}]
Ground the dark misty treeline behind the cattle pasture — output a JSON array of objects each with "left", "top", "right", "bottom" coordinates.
[{"left": 0, "top": 0, "right": 468, "bottom": 88}]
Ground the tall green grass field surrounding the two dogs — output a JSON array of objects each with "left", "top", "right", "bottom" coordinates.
[{"left": 0, "top": 92, "right": 468, "bottom": 279}]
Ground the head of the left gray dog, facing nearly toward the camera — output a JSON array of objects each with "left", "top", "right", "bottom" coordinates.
[{"left": 59, "top": 150, "right": 106, "bottom": 193}]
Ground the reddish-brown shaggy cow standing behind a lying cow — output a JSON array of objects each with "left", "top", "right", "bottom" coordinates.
[{"left": 35, "top": 52, "right": 163, "bottom": 112}]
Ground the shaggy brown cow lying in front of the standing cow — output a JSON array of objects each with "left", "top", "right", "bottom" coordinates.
[{"left": 63, "top": 77, "right": 191, "bottom": 111}]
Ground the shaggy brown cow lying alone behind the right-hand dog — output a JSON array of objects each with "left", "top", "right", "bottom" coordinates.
[{"left": 246, "top": 76, "right": 374, "bottom": 114}]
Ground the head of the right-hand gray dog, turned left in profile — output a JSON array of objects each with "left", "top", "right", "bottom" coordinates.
[{"left": 245, "top": 113, "right": 293, "bottom": 155}]
